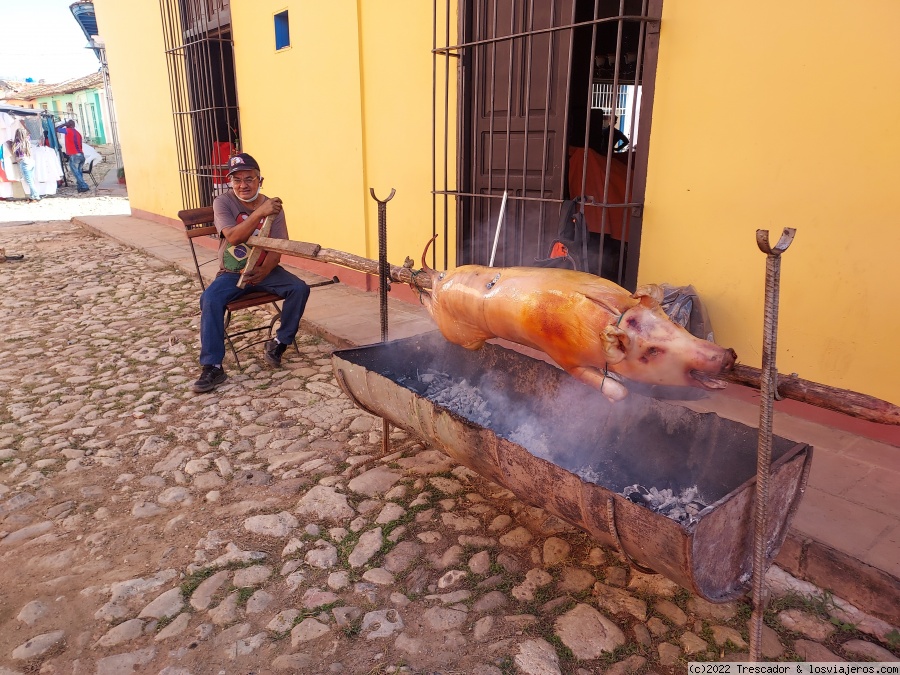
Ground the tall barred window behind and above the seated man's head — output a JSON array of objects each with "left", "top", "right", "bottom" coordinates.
[{"left": 159, "top": 0, "right": 240, "bottom": 209}]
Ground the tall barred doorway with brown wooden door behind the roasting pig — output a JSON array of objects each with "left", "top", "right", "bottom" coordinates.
[{"left": 433, "top": 0, "right": 662, "bottom": 288}]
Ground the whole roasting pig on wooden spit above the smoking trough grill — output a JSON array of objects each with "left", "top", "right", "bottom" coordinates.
[{"left": 412, "top": 242, "right": 736, "bottom": 401}]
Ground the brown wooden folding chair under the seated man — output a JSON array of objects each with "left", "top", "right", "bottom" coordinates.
[{"left": 178, "top": 206, "right": 340, "bottom": 368}]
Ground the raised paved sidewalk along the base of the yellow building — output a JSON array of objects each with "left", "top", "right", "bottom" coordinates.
[{"left": 73, "top": 214, "right": 900, "bottom": 626}]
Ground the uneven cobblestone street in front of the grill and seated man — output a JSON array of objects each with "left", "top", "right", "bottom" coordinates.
[{"left": 0, "top": 219, "right": 900, "bottom": 675}]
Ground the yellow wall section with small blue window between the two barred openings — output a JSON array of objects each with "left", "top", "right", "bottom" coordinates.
[{"left": 231, "top": 0, "right": 448, "bottom": 264}]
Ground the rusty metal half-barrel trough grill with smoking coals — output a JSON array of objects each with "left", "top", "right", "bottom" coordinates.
[{"left": 332, "top": 331, "right": 812, "bottom": 602}]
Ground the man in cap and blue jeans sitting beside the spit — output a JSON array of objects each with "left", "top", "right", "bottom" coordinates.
[{"left": 193, "top": 153, "right": 309, "bottom": 394}]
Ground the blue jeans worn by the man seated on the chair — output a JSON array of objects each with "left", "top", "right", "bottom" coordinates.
[{"left": 200, "top": 265, "right": 309, "bottom": 366}]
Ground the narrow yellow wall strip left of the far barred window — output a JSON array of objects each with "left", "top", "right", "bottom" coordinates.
[{"left": 94, "top": 0, "right": 181, "bottom": 218}]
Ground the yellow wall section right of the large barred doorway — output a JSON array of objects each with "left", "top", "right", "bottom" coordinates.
[{"left": 639, "top": 0, "right": 900, "bottom": 404}]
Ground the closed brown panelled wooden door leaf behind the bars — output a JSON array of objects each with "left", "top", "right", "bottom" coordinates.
[{"left": 458, "top": 0, "right": 574, "bottom": 266}]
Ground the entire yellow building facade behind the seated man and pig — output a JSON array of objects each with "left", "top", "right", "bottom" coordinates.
[{"left": 95, "top": 0, "right": 900, "bottom": 404}]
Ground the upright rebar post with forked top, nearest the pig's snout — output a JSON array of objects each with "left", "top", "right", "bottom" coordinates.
[{"left": 750, "top": 227, "right": 797, "bottom": 661}]
